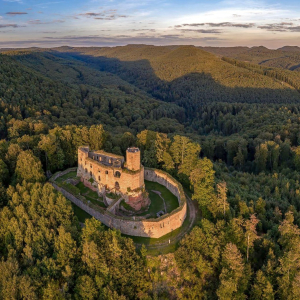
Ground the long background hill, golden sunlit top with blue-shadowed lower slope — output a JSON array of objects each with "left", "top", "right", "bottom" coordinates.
[{"left": 45, "top": 45, "right": 299, "bottom": 111}]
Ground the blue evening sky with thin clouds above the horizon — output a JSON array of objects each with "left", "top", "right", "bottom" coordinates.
[{"left": 0, "top": 0, "right": 300, "bottom": 49}]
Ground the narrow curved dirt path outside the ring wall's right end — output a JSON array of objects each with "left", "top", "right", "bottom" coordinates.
[{"left": 137, "top": 194, "right": 197, "bottom": 249}]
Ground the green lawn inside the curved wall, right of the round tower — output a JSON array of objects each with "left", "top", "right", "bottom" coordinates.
[{"left": 140, "top": 180, "right": 179, "bottom": 218}]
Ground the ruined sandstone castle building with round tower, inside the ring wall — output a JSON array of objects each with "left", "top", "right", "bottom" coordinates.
[{"left": 77, "top": 146, "right": 150, "bottom": 210}]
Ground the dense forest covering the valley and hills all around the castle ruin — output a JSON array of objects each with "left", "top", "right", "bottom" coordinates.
[{"left": 0, "top": 45, "right": 300, "bottom": 300}]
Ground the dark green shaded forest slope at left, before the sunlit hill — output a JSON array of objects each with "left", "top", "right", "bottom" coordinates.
[{"left": 0, "top": 53, "right": 185, "bottom": 137}]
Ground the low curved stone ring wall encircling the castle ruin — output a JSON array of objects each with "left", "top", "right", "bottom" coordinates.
[{"left": 51, "top": 169, "right": 187, "bottom": 238}]
